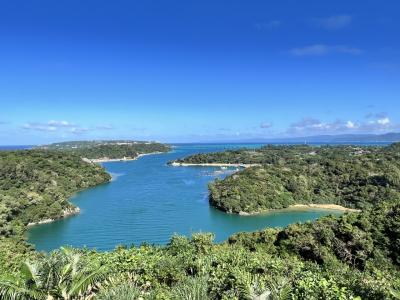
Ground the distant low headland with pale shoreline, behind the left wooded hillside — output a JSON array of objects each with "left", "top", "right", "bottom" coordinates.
[{"left": 40, "top": 140, "right": 171, "bottom": 159}]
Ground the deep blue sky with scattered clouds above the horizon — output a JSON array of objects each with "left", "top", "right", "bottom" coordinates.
[{"left": 0, "top": 0, "right": 400, "bottom": 144}]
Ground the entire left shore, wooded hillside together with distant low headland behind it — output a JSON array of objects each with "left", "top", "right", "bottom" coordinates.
[{"left": 0, "top": 140, "right": 170, "bottom": 270}]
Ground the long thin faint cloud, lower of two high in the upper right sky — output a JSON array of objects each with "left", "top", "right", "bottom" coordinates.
[{"left": 289, "top": 44, "right": 363, "bottom": 56}]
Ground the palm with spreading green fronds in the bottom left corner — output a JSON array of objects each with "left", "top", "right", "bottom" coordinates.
[{"left": 0, "top": 248, "right": 106, "bottom": 300}]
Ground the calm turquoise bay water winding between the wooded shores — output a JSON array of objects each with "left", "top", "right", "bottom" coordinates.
[{"left": 28, "top": 144, "right": 344, "bottom": 251}]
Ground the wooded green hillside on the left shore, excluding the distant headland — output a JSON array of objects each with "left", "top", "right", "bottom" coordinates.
[{"left": 0, "top": 150, "right": 111, "bottom": 268}]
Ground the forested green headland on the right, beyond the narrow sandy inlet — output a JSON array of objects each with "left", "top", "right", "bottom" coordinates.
[{"left": 173, "top": 144, "right": 400, "bottom": 213}]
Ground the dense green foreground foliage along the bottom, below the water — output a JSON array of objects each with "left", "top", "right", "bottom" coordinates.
[{"left": 0, "top": 200, "right": 400, "bottom": 299}]
